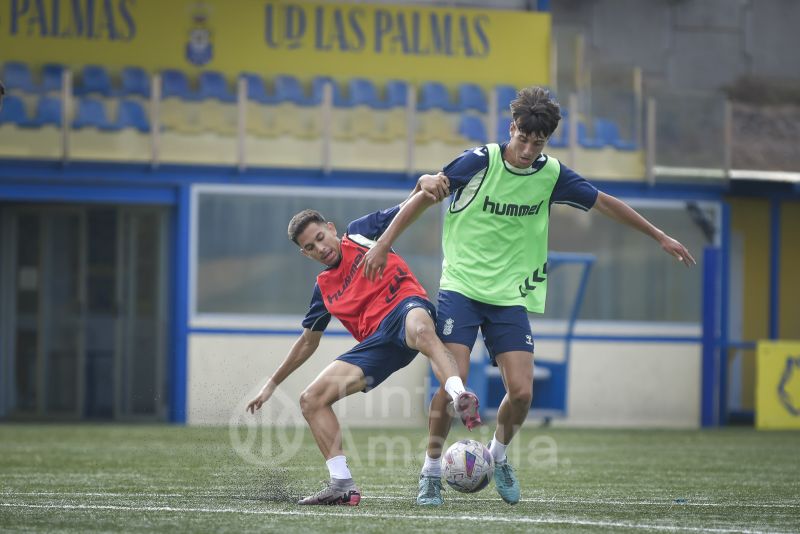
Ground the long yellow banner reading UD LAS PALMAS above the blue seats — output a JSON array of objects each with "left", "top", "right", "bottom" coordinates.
[{"left": 0, "top": 0, "right": 550, "bottom": 87}]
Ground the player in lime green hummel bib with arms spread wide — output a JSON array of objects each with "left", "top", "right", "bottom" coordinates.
[{"left": 364, "top": 87, "right": 695, "bottom": 506}]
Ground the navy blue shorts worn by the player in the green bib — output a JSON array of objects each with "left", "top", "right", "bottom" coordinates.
[{"left": 436, "top": 289, "right": 533, "bottom": 367}]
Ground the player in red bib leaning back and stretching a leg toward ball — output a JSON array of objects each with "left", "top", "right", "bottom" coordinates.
[{"left": 247, "top": 193, "right": 480, "bottom": 506}]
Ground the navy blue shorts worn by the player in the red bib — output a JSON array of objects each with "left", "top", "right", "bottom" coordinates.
[{"left": 336, "top": 297, "right": 436, "bottom": 392}]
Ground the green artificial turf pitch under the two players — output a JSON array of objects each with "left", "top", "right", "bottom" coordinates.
[{"left": 0, "top": 424, "right": 800, "bottom": 533}]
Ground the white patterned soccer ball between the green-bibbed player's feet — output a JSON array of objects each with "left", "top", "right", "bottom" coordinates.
[{"left": 442, "top": 439, "right": 494, "bottom": 493}]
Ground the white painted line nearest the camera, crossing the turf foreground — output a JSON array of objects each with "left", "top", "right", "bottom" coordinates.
[{"left": 0, "top": 502, "right": 784, "bottom": 534}]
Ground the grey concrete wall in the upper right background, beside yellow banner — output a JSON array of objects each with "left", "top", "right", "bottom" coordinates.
[{"left": 551, "top": 0, "right": 800, "bottom": 91}]
